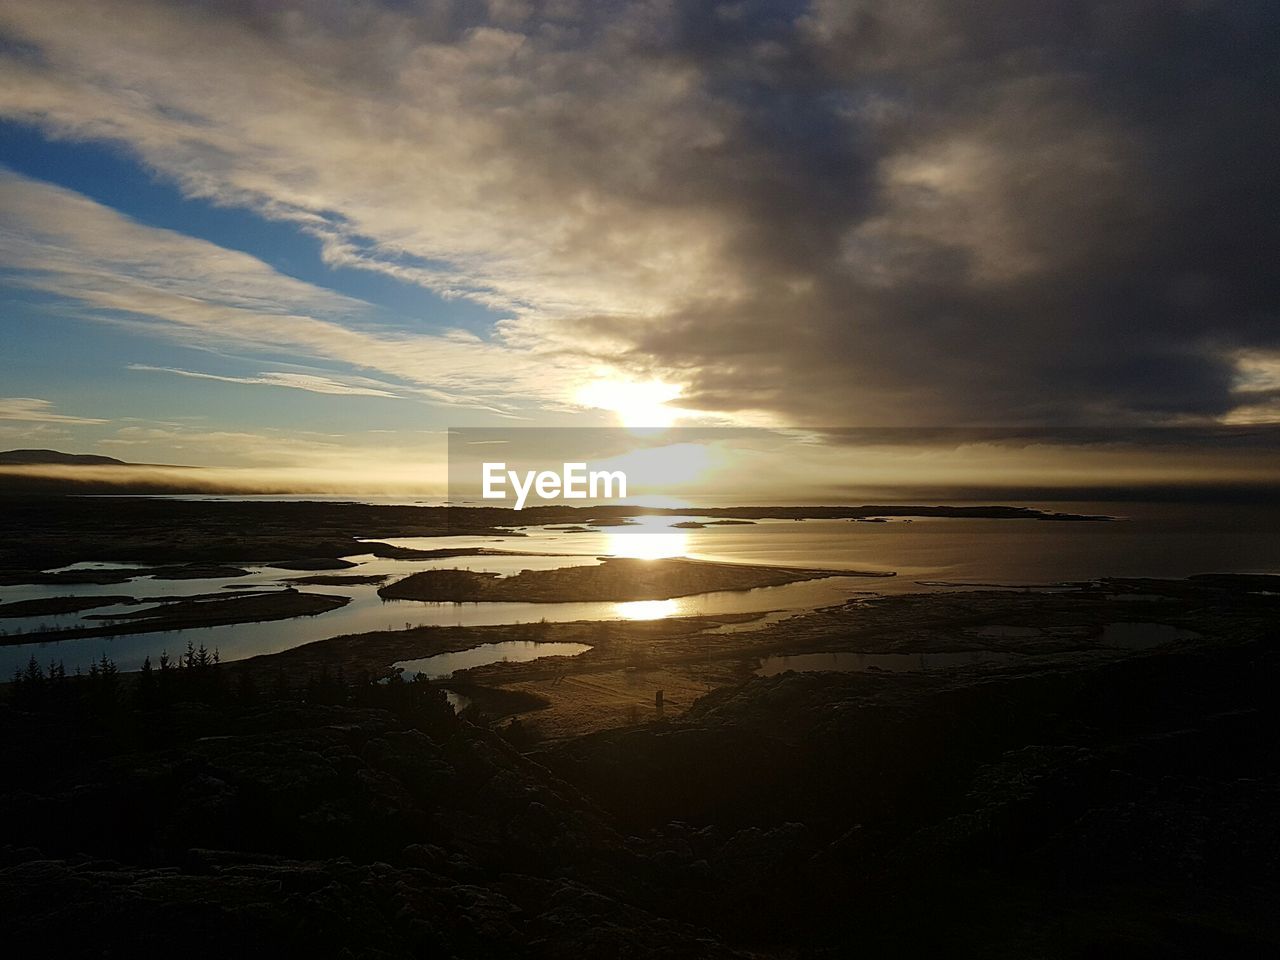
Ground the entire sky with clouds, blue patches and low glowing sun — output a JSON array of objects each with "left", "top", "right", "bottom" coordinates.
[{"left": 0, "top": 0, "right": 1280, "bottom": 496}]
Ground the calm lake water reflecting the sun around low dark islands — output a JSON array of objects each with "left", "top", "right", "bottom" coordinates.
[{"left": 0, "top": 503, "right": 1280, "bottom": 676}]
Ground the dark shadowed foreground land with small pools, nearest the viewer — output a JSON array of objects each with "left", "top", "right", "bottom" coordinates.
[{"left": 0, "top": 577, "right": 1280, "bottom": 960}]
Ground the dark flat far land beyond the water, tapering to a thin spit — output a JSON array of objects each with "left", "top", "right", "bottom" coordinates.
[{"left": 0, "top": 497, "right": 1108, "bottom": 585}]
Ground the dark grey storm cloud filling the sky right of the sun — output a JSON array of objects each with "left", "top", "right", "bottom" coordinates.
[{"left": 586, "top": 3, "right": 1280, "bottom": 422}]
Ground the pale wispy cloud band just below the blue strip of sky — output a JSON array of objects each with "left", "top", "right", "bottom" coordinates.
[{"left": 0, "top": 169, "right": 593, "bottom": 413}]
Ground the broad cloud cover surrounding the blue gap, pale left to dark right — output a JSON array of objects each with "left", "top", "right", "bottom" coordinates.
[{"left": 0, "top": 0, "right": 1280, "bottom": 425}]
